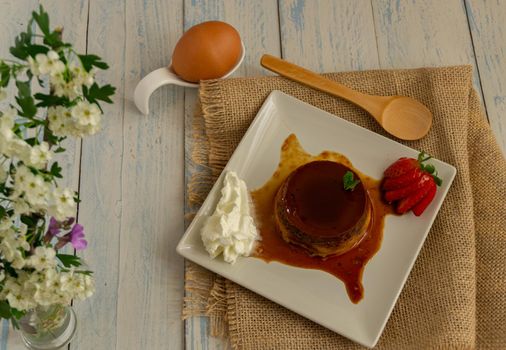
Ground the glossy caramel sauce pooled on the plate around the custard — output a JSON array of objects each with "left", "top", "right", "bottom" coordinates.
[{"left": 251, "top": 134, "right": 392, "bottom": 303}]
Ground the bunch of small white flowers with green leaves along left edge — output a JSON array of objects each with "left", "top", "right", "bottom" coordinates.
[{"left": 0, "top": 7, "right": 115, "bottom": 348}]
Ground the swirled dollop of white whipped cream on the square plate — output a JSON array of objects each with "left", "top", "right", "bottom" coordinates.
[{"left": 201, "top": 171, "right": 258, "bottom": 264}]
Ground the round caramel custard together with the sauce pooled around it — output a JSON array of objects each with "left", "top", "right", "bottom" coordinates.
[{"left": 251, "top": 134, "right": 392, "bottom": 303}]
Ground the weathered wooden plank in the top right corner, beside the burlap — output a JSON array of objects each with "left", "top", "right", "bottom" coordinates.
[{"left": 466, "top": 0, "right": 506, "bottom": 153}]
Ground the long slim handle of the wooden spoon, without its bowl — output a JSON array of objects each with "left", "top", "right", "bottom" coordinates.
[{"left": 260, "top": 55, "right": 392, "bottom": 121}]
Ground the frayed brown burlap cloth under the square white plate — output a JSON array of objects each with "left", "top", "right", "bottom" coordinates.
[{"left": 184, "top": 66, "right": 506, "bottom": 350}]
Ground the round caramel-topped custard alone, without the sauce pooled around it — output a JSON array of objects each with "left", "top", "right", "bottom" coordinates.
[{"left": 274, "top": 160, "right": 372, "bottom": 257}]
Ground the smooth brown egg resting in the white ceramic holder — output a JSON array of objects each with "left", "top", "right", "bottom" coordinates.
[{"left": 172, "top": 21, "right": 242, "bottom": 82}]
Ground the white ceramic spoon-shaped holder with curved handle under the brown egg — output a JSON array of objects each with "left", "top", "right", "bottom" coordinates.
[{"left": 134, "top": 41, "right": 246, "bottom": 115}]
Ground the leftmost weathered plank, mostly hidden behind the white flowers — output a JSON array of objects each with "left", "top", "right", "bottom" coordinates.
[{"left": 0, "top": 0, "right": 88, "bottom": 350}]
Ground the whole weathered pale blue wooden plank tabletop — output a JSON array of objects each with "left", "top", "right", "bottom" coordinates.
[{"left": 0, "top": 0, "right": 506, "bottom": 350}]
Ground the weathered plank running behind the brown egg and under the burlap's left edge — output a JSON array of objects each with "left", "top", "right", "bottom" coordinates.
[{"left": 184, "top": 0, "right": 280, "bottom": 350}]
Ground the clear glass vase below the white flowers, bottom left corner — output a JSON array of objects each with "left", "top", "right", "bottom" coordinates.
[{"left": 19, "top": 305, "right": 77, "bottom": 350}]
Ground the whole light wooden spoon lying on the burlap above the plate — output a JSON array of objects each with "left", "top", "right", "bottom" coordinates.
[{"left": 260, "top": 55, "right": 432, "bottom": 140}]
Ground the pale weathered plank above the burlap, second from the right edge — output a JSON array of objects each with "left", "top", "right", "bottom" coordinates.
[{"left": 372, "top": 0, "right": 481, "bottom": 93}]
